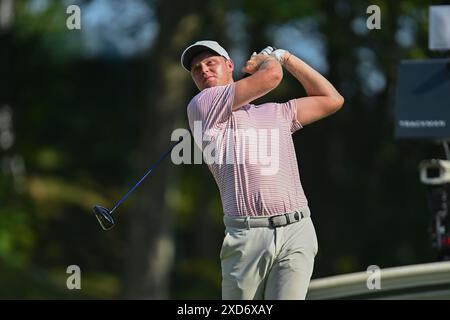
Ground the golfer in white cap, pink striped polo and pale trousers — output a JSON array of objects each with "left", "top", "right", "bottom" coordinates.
[{"left": 181, "top": 40, "right": 344, "bottom": 299}]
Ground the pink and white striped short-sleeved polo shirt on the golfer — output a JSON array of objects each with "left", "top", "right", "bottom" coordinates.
[{"left": 187, "top": 83, "right": 308, "bottom": 216}]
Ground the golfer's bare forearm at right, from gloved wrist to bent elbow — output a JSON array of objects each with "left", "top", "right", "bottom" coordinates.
[{"left": 284, "top": 53, "right": 341, "bottom": 99}]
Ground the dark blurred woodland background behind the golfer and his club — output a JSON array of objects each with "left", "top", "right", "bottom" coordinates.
[{"left": 0, "top": 0, "right": 443, "bottom": 299}]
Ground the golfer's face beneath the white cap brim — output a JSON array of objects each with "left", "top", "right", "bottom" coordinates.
[{"left": 191, "top": 51, "right": 234, "bottom": 91}]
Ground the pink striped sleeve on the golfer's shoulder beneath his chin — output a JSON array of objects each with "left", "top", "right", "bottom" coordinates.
[{"left": 187, "top": 83, "right": 235, "bottom": 140}]
